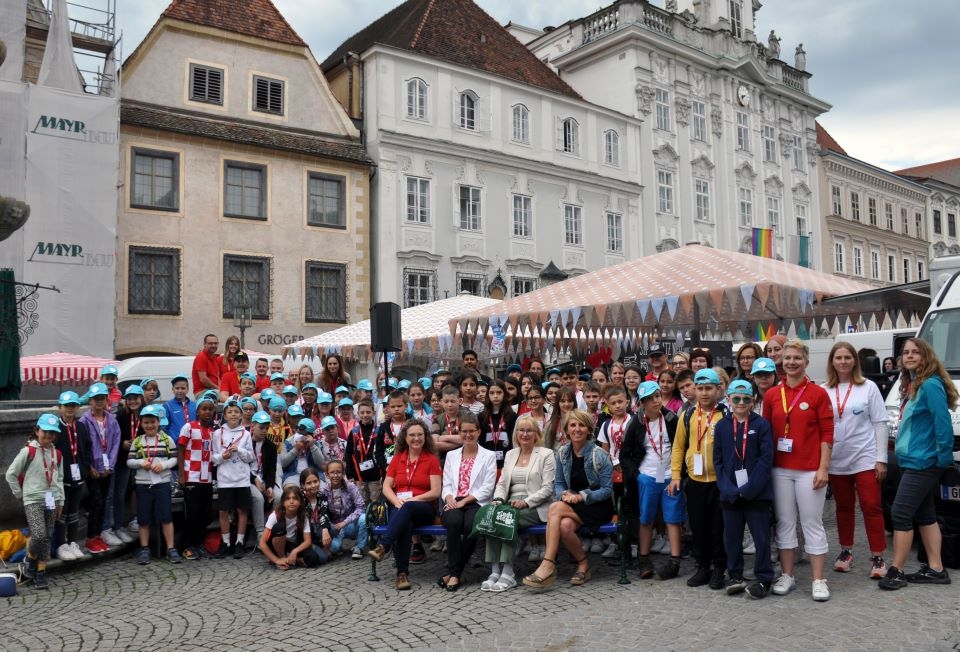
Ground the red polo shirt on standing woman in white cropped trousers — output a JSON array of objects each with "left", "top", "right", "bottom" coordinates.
[{"left": 763, "top": 378, "right": 833, "bottom": 471}]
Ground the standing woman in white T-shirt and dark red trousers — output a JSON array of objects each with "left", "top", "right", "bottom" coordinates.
[{"left": 823, "top": 342, "right": 887, "bottom": 580}]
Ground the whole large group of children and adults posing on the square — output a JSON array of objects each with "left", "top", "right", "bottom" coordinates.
[{"left": 6, "top": 335, "right": 958, "bottom": 601}]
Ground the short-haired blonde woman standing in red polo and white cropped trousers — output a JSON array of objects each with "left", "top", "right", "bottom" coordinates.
[{"left": 763, "top": 340, "right": 833, "bottom": 602}]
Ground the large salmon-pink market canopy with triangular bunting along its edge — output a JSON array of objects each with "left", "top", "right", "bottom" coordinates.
[{"left": 450, "top": 245, "right": 870, "bottom": 355}]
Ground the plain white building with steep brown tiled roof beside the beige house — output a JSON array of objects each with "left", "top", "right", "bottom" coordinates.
[{"left": 322, "top": 0, "right": 643, "bottom": 307}]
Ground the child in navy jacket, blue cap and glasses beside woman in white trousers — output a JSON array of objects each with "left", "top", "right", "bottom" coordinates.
[{"left": 713, "top": 380, "right": 773, "bottom": 599}]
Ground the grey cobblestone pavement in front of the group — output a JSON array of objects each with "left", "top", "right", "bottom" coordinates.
[{"left": 0, "top": 502, "right": 960, "bottom": 652}]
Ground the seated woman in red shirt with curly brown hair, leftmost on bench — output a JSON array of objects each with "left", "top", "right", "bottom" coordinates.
[{"left": 367, "top": 419, "right": 443, "bottom": 591}]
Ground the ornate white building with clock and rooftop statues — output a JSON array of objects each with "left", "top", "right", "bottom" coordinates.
[{"left": 516, "top": 0, "right": 830, "bottom": 269}]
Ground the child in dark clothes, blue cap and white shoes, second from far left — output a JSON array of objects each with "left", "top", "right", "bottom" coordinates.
[{"left": 56, "top": 392, "right": 93, "bottom": 561}]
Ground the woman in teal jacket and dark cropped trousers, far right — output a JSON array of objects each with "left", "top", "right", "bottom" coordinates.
[{"left": 880, "top": 338, "right": 958, "bottom": 591}]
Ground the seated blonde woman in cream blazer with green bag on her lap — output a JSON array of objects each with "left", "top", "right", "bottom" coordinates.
[{"left": 480, "top": 415, "right": 557, "bottom": 593}]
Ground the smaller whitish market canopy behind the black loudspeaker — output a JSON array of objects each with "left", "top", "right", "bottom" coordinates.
[{"left": 283, "top": 294, "right": 502, "bottom": 361}]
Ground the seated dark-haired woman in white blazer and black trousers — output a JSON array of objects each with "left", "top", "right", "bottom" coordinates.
[{"left": 437, "top": 414, "right": 497, "bottom": 591}]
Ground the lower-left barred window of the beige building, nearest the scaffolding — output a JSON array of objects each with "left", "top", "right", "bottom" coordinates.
[{"left": 127, "top": 247, "right": 180, "bottom": 315}]
